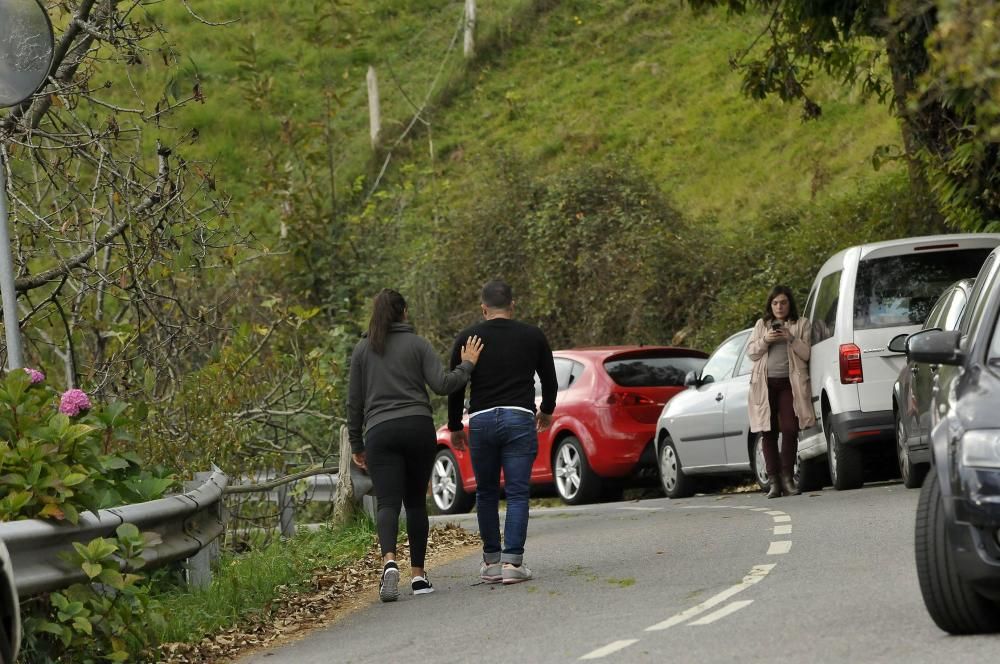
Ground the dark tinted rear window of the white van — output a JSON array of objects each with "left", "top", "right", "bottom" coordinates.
[{"left": 854, "top": 248, "right": 990, "bottom": 330}]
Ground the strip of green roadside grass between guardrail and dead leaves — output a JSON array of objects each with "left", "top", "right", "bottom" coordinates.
[{"left": 159, "top": 518, "right": 375, "bottom": 643}]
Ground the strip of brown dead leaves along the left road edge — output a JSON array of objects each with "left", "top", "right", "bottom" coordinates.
[{"left": 160, "top": 524, "right": 479, "bottom": 664}]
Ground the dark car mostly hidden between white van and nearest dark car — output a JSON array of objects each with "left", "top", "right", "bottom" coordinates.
[{"left": 889, "top": 279, "right": 975, "bottom": 489}]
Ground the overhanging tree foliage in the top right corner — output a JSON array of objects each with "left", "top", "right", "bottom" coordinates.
[{"left": 687, "top": 0, "right": 1000, "bottom": 231}]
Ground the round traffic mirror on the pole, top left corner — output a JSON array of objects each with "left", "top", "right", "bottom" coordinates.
[{"left": 0, "top": 0, "right": 55, "bottom": 108}]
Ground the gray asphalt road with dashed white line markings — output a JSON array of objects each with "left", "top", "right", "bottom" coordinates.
[{"left": 240, "top": 483, "right": 1000, "bottom": 664}]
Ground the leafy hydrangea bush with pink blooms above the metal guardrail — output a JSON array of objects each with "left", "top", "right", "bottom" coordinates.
[{"left": 0, "top": 370, "right": 173, "bottom": 523}]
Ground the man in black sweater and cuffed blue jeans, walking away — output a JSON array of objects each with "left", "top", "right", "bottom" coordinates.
[{"left": 448, "top": 280, "right": 557, "bottom": 584}]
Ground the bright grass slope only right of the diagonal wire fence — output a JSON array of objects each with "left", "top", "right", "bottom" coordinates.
[{"left": 437, "top": 0, "right": 898, "bottom": 223}]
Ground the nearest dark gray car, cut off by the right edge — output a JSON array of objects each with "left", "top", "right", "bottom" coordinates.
[{"left": 907, "top": 249, "right": 1000, "bottom": 634}]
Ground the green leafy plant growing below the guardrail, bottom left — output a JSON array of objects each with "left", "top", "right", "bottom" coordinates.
[{"left": 22, "top": 523, "right": 165, "bottom": 664}]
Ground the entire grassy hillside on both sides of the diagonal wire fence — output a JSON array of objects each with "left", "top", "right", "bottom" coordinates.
[{"left": 125, "top": 0, "right": 897, "bottom": 229}]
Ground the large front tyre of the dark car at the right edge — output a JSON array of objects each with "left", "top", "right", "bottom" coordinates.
[{"left": 915, "top": 469, "right": 1000, "bottom": 634}]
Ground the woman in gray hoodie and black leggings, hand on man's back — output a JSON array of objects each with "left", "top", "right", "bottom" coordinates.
[{"left": 347, "top": 288, "right": 483, "bottom": 602}]
